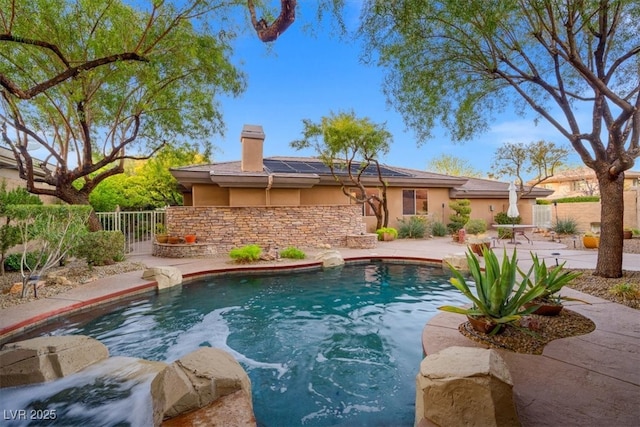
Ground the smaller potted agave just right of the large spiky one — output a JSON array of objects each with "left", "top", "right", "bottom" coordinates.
[{"left": 525, "top": 253, "right": 586, "bottom": 316}]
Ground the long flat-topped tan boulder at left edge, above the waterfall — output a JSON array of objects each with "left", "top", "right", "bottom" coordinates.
[{"left": 0, "top": 335, "right": 109, "bottom": 387}]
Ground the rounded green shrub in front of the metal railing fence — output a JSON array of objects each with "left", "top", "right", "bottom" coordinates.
[{"left": 74, "top": 231, "right": 124, "bottom": 266}]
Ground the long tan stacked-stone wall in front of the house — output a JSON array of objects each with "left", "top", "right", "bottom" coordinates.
[{"left": 166, "top": 205, "right": 365, "bottom": 253}]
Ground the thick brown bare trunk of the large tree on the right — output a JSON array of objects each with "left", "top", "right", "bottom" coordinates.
[{"left": 594, "top": 169, "right": 624, "bottom": 278}]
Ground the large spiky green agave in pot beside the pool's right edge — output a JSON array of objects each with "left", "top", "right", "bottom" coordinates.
[{"left": 438, "top": 249, "right": 545, "bottom": 335}]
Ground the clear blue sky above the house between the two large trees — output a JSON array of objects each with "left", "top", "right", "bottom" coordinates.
[{"left": 213, "top": 2, "right": 578, "bottom": 180}]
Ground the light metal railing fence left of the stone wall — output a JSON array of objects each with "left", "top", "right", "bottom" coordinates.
[{"left": 97, "top": 210, "right": 165, "bottom": 254}]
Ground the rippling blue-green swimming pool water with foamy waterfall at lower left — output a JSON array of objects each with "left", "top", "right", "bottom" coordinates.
[{"left": 2, "top": 263, "right": 465, "bottom": 427}]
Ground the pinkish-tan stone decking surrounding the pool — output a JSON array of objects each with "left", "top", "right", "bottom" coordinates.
[{"left": 0, "top": 238, "right": 640, "bottom": 426}]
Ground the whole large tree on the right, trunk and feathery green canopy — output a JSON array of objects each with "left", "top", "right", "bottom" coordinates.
[{"left": 361, "top": 0, "right": 640, "bottom": 277}]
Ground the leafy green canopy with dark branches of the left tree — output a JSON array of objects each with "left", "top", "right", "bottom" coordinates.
[{"left": 0, "top": 0, "right": 245, "bottom": 229}]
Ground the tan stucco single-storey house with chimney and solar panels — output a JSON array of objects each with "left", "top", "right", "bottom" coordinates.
[{"left": 168, "top": 125, "right": 551, "bottom": 252}]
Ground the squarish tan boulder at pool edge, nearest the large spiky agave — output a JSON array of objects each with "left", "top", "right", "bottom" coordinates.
[{"left": 416, "top": 347, "right": 520, "bottom": 427}]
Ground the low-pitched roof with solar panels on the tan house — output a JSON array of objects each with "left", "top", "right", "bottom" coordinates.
[{"left": 171, "top": 156, "right": 553, "bottom": 198}]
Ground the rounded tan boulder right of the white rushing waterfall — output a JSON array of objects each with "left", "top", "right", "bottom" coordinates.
[{"left": 151, "top": 347, "right": 253, "bottom": 425}]
